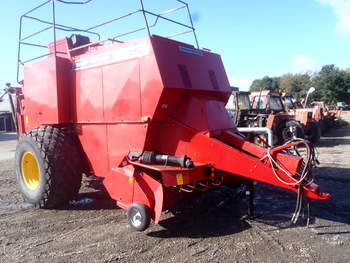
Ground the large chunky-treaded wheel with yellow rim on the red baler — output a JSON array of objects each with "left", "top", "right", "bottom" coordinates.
[{"left": 15, "top": 126, "right": 82, "bottom": 208}]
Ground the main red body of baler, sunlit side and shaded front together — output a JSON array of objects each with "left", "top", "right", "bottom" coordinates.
[{"left": 72, "top": 36, "right": 235, "bottom": 173}]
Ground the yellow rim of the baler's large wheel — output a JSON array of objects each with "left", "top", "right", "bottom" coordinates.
[{"left": 21, "top": 152, "right": 40, "bottom": 190}]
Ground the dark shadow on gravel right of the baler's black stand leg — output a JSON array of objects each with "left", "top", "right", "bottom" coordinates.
[{"left": 224, "top": 177, "right": 350, "bottom": 234}]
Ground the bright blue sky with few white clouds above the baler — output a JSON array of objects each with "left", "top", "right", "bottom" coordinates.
[{"left": 0, "top": 0, "right": 350, "bottom": 93}]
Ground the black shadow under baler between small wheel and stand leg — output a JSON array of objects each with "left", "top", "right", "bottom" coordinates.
[{"left": 147, "top": 187, "right": 251, "bottom": 238}]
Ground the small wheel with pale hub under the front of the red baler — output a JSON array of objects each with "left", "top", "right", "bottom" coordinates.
[{"left": 127, "top": 203, "right": 151, "bottom": 231}]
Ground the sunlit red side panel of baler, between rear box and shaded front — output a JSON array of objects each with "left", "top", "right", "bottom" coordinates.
[{"left": 71, "top": 39, "right": 156, "bottom": 171}]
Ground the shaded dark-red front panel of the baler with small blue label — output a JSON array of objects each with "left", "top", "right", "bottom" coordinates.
[{"left": 152, "top": 37, "right": 235, "bottom": 135}]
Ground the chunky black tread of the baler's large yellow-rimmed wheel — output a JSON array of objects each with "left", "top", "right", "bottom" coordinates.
[{"left": 19, "top": 126, "right": 82, "bottom": 208}]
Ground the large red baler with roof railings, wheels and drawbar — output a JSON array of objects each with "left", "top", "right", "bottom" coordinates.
[{"left": 10, "top": 0, "right": 330, "bottom": 231}]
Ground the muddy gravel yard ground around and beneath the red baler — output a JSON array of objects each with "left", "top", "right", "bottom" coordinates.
[{"left": 0, "top": 115, "right": 350, "bottom": 263}]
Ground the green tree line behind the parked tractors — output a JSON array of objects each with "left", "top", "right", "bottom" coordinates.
[{"left": 250, "top": 65, "right": 350, "bottom": 104}]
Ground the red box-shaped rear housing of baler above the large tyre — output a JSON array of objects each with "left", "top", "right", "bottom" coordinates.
[{"left": 23, "top": 56, "right": 71, "bottom": 131}]
